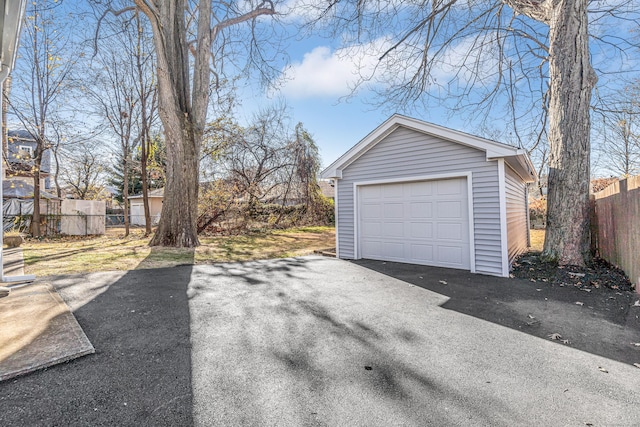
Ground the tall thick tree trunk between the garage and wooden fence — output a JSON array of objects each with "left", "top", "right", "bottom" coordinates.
[{"left": 543, "top": 0, "right": 596, "bottom": 265}]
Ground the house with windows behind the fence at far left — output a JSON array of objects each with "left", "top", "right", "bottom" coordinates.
[{"left": 4, "top": 130, "right": 51, "bottom": 190}]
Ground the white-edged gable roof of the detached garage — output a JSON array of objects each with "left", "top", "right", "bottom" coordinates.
[{"left": 321, "top": 114, "right": 537, "bottom": 182}]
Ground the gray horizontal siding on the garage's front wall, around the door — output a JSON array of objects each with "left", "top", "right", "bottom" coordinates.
[{"left": 337, "top": 127, "right": 502, "bottom": 275}]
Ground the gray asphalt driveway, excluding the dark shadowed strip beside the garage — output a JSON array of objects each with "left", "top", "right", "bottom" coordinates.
[{"left": 0, "top": 257, "right": 640, "bottom": 426}]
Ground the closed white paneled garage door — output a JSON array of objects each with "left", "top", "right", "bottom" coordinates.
[{"left": 358, "top": 178, "right": 470, "bottom": 270}]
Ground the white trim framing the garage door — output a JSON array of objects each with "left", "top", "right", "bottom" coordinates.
[{"left": 350, "top": 172, "right": 476, "bottom": 275}]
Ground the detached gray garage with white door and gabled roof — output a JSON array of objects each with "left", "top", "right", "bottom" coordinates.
[{"left": 322, "top": 115, "right": 536, "bottom": 276}]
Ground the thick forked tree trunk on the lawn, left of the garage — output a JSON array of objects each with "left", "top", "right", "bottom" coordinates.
[{"left": 141, "top": 0, "right": 211, "bottom": 247}]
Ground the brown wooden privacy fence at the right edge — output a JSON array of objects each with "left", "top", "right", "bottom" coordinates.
[{"left": 592, "top": 176, "right": 640, "bottom": 290}]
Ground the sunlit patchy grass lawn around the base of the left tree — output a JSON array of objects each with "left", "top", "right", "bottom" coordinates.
[{"left": 22, "top": 227, "right": 335, "bottom": 276}]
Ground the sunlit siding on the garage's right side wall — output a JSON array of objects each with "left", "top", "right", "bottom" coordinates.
[{"left": 504, "top": 166, "right": 529, "bottom": 263}]
